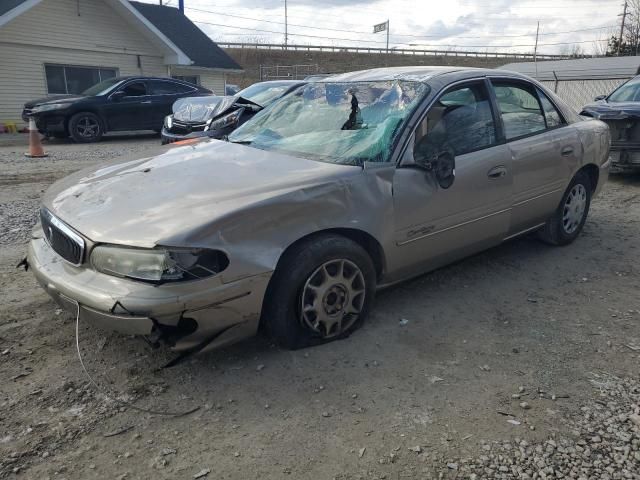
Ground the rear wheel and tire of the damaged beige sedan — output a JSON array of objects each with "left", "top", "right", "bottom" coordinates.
[{"left": 538, "top": 172, "right": 593, "bottom": 245}]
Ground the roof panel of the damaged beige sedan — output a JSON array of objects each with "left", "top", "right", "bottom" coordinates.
[{"left": 322, "top": 66, "right": 527, "bottom": 82}]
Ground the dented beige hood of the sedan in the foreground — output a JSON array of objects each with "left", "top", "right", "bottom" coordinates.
[{"left": 43, "top": 140, "right": 361, "bottom": 247}]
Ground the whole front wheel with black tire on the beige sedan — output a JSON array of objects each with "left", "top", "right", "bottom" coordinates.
[{"left": 262, "top": 235, "right": 376, "bottom": 350}]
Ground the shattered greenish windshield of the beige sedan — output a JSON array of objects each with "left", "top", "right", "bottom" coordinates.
[{"left": 229, "top": 80, "right": 429, "bottom": 165}]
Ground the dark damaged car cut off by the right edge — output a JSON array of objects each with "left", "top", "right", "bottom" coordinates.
[{"left": 580, "top": 76, "right": 640, "bottom": 173}]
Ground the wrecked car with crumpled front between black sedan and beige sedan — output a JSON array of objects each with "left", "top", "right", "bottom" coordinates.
[{"left": 162, "top": 80, "right": 305, "bottom": 145}]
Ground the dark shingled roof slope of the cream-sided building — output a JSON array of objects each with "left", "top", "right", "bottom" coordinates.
[{"left": 129, "top": 2, "right": 242, "bottom": 70}]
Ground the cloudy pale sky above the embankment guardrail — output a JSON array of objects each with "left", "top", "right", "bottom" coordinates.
[{"left": 138, "top": 0, "right": 622, "bottom": 54}]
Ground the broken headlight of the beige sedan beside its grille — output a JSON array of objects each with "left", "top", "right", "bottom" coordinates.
[{"left": 91, "top": 245, "right": 229, "bottom": 283}]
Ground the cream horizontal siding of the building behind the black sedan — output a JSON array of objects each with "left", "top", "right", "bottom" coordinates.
[{"left": 0, "top": 0, "right": 239, "bottom": 122}]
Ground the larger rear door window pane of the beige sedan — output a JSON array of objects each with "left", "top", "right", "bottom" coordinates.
[{"left": 492, "top": 81, "right": 547, "bottom": 140}]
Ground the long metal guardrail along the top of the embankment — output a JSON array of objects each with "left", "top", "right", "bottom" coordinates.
[{"left": 217, "top": 42, "right": 569, "bottom": 60}]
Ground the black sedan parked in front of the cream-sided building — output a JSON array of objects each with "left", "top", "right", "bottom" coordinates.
[{"left": 22, "top": 77, "right": 212, "bottom": 143}]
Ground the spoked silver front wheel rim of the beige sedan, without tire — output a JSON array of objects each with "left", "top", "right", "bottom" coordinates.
[{"left": 301, "top": 259, "right": 366, "bottom": 338}]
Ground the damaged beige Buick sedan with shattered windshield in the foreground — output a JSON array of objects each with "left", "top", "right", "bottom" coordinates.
[{"left": 28, "top": 67, "right": 610, "bottom": 351}]
